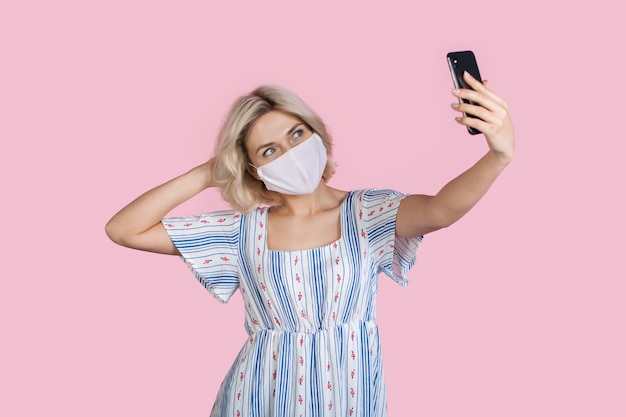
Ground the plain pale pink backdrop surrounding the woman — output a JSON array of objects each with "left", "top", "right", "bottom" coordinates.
[{"left": 0, "top": 0, "right": 626, "bottom": 417}]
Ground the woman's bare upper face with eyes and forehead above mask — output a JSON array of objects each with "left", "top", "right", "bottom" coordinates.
[{"left": 246, "top": 110, "right": 313, "bottom": 167}]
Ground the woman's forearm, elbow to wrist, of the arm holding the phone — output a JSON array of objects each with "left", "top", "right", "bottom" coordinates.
[{"left": 429, "top": 151, "right": 510, "bottom": 227}]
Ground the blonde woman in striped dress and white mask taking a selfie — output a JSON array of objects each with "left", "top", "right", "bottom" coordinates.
[{"left": 106, "top": 74, "right": 514, "bottom": 416}]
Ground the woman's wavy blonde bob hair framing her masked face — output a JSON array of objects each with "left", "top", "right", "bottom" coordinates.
[{"left": 210, "top": 85, "right": 335, "bottom": 213}]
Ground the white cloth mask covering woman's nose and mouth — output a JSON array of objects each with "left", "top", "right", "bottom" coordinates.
[{"left": 256, "top": 133, "right": 327, "bottom": 195}]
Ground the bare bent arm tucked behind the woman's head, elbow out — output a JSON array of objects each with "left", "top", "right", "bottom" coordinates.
[{"left": 105, "top": 162, "right": 212, "bottom": 255}]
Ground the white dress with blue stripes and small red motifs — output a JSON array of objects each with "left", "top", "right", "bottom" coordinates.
[{"left": 163, "top": 189, "right": 422, "bottom": 417}]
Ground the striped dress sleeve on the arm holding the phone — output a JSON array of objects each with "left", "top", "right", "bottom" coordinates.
[{"left": 361, "top": 189, "right": 424, "bottom": 286}]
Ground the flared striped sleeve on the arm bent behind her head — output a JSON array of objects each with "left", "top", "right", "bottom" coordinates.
[{"left": 161, "top": 210, "right": 241, "bottom": 303}]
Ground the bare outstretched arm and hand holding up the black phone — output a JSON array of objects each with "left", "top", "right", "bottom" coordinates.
[{"left": 396, "top": 73, "right": 515, "bottom": 237}]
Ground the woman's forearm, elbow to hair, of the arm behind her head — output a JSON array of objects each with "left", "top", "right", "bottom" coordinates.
[{"left": 106, "top": 163, "right": 212, "bottom": 245}]
